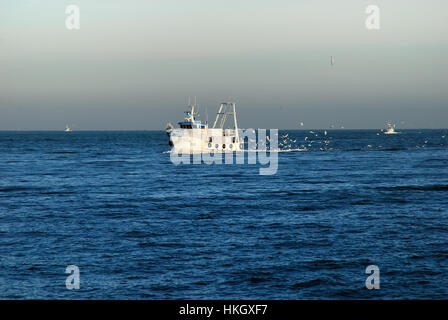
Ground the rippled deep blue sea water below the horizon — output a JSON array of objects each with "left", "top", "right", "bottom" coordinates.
[{"left": 0, "top": 130, "right": 448, "bottom": 299}]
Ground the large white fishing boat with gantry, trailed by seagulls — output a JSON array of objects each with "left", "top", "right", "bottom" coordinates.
[{"left": 166, "top": 102, "right": 244, "bottom": 153}]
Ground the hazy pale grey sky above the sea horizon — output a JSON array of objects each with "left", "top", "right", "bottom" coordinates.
[{"left": 0, "top": 0, "right": 448, "bottom": 130}]
